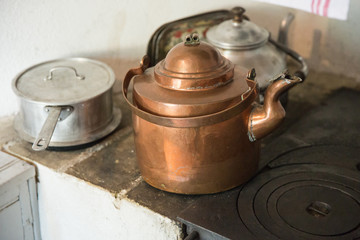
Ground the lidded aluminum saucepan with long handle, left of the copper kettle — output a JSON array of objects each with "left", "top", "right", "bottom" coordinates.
[{"left": 12, "top": 58, "right": 121, "bottom": 151}]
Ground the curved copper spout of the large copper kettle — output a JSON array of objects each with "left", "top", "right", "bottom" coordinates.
[{"left": 248, "top": 76, "right": 302, "bottom": 142}]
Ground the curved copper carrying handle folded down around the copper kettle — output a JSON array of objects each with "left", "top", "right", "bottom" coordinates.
[{"left": 122, "top": 55, "right": 257, "bottom": 128}]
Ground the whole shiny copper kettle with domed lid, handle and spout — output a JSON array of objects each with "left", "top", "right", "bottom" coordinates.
[{"left": 123, "top": 34, "right": 301, "bottom": 194}]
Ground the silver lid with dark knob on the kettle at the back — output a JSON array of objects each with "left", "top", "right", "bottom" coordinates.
[{"left": 206, "top": 7, "right": 270, "bottom": 50}]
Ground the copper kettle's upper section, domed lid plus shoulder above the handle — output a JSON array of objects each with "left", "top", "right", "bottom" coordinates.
[{"left": 133, "top": 34, "right": 253, "bottom": 117}]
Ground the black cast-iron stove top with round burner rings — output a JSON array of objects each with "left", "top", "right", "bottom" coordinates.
[{"left": 178, "top": 89, "right": 360, "bottom": 240}]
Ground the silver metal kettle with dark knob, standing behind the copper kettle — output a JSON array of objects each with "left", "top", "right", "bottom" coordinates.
[{"left": 206, "top": 7, "right": 308, "bottom": 102}]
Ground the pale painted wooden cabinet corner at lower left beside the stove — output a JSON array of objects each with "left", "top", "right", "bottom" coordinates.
[{"left": 0, "top": 151, "right": 41, "bottom": 240}]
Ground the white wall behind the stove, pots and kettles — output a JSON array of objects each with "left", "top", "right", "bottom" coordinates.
[{"left": 0, "top": 0, "right": 360, "bottom": 116}]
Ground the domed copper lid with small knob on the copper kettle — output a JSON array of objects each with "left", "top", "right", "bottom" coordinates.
[{"left": 154, "top": 34, "right": 234, "bottom": 91}]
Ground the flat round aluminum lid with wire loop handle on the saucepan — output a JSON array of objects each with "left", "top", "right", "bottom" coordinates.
[{"left": 13, "top": 58, "right": 115, "bottom": 105}]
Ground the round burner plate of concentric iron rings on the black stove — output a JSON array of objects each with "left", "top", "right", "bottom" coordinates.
[{"left": 238, "top": 164, "right": 360, "bottom": 239}]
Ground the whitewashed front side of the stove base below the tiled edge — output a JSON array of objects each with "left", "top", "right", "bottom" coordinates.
[{"left": 36, "top": 164, "right": 181, "bottom": 240}]
